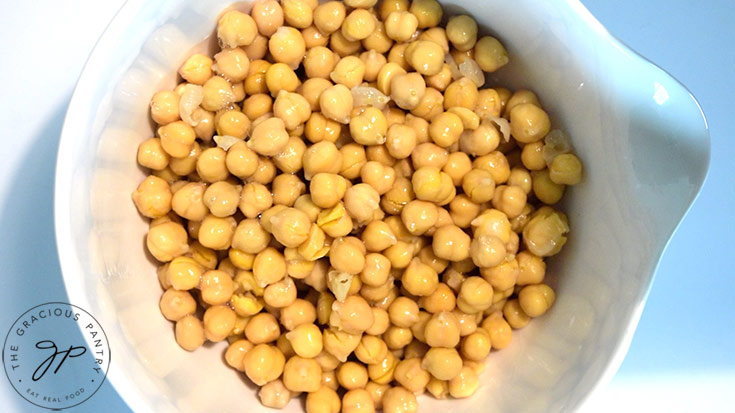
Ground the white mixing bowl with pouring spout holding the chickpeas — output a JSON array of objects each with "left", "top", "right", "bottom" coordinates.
[{"left": 55, "top": 0, "right": 709, "bottom": 413}]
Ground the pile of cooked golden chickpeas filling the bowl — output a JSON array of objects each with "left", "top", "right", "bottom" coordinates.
[{"left": 132, "top": 0, "right": 582, "bottom": 413}]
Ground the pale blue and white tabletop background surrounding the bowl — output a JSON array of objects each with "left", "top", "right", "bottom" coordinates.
[{"left": 0, "top": 0, "right": 735, "bottom": 411}]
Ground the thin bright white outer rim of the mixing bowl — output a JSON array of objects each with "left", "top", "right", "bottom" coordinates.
[{"left": 54, "top": 0, "right": 711, "bottom": 411}]
